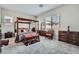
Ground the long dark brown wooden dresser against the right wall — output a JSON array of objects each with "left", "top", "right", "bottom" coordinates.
[{"left": 59, "top": 31, "right": 79, "bottom": 45}]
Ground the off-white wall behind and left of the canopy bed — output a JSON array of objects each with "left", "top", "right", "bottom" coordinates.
[{"left": 1, "top": 8, "right": 35, "bottom": 33}]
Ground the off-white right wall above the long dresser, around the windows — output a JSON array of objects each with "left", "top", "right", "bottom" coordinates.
[{"left": 38, "top": 4, "right": 79, "bottom": 39}]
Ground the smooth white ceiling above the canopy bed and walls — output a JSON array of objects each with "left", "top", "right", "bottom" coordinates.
[{"left": 0, "top": 4, "right": 60, "bottom": 16}]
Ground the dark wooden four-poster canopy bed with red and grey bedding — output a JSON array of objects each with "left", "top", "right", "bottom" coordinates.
[{"left": 15, "top": 17, "right": 40, "bottom": 44}]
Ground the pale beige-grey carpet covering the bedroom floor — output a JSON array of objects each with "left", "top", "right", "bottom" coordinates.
[{"left": 2, "top": 37, "right": 79, "bottom": 54}]
